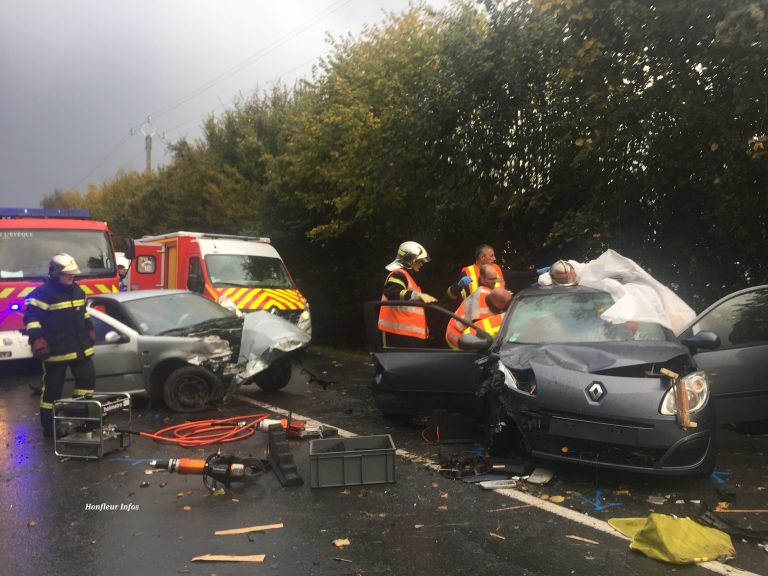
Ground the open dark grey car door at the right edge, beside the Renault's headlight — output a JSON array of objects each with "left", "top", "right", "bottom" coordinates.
[{"left": 683, "top": 286, "right": 768, "bottom": 422}]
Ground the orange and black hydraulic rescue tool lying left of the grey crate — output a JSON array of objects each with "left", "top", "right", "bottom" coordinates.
[{"left": 149, "top": 452, "right": 270, "bottom": 490}]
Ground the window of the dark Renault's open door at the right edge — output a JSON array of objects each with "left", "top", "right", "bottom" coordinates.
[{"left": 692, "top": 288, "right": 768, "bottom": 348}]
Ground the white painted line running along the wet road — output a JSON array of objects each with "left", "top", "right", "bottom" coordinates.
[{"left": 237, "top": 395, "right": 760, "bottom": 576}]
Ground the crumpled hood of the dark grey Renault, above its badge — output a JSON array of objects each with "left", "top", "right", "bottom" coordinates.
[{"left": 500, "top": 341, "right": 687, "bottom": 374}]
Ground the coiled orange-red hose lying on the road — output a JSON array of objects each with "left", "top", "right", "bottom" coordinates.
[{"left": 139, "top": 414, "right": 270, "bottom": 448}]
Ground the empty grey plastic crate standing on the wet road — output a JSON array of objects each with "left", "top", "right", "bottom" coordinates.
[{"left": 309, "top": 434, "right": 395, "bottom": 488}]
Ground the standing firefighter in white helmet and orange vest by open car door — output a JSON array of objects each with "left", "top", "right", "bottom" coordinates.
[{"left": 378, "top": 241, "right": 437, "bottom": 348}]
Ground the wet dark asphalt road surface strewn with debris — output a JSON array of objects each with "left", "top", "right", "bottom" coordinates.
[{"left": 0, "top": 353, "right": 768, "bottom": 576}]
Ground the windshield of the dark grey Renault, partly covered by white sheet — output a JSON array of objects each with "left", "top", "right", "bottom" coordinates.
[{"left": 501, "top": 291, "right": 668, "bottom": 344}]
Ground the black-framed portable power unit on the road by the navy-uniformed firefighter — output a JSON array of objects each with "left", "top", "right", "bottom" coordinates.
[{"left": 53, "top": 393, "right": 131, "bottom": 460}]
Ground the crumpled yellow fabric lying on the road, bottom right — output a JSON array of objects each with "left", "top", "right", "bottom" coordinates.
[{"left": 608, "top": 514, "right": 736, "bottom": 564}]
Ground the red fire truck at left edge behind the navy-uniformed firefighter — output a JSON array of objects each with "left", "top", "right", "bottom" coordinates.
[{"left": 0, "top": 208, "right": 119, "bottom": 360}]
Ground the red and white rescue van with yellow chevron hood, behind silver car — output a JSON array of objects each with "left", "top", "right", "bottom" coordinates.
[{"left": 126, "top": 232, "right": 312, "bottom": 334}]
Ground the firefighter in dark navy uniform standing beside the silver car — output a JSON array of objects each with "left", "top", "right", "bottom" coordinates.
[{"left": 24, "top": 253, "right": 96, "bottom": 436}]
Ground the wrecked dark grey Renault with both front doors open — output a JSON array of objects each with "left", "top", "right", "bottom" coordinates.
[{"left": 367, "top": 286, "right": 768, "bottom": 475}]
